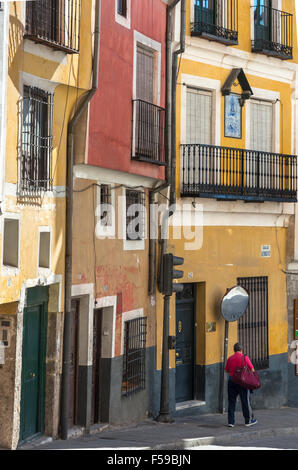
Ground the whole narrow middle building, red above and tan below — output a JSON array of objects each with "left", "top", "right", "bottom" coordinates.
[{"left": 72, "top": 0, "right": 167, "bottom": 427}]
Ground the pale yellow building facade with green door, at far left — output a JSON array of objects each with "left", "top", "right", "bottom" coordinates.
[{"left": 0, "top": 0, "right": 94, "bottom": 448}]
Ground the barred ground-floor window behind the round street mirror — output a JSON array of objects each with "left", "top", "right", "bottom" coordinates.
[{"left": 237, "top": 277, "right": 269, "bottom": 369}]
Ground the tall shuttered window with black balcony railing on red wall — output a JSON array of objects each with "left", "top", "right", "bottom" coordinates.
[{"left": 132, "top": 44, "right": 165, "bottom": 165}]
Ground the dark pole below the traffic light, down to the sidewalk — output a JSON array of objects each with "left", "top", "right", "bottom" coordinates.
[{"left": 157, "top": 295, "right": 174, "bottom": 423}]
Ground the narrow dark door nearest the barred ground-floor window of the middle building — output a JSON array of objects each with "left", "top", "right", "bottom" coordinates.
[{"left": 91, "top": 309, "right": 102, "bottom": 424}]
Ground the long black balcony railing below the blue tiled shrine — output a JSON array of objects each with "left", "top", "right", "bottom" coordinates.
[{"left": 181, "top": 144, "right": 297, "bottom": 202}]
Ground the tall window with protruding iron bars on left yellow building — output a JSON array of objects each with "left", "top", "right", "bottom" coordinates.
[{"left": 18, "top": 86, "right": 53, "bottom": 196}]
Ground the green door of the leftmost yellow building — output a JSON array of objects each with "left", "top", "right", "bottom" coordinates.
[{"left": 19, "top": 287, "right": 48, "bottom": 441}]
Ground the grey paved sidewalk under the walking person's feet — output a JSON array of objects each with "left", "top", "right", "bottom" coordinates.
[{"left": 20, "top": 408, "right": 298, "bottom": 450}]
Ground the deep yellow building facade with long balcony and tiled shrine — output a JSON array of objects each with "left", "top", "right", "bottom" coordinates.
[{"left": 157, "top": 0, "right": 297, "bottom": 414}]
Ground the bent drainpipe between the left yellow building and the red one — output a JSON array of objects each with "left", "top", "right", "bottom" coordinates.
[{"left": 61, "top": 0, "right": 101, "bottom": 439}]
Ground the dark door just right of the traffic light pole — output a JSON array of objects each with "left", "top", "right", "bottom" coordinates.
[{"left": 176, "top": 284, "right": 195, "bottom": 402}]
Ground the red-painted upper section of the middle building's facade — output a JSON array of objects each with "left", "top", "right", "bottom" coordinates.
[{"left": 88, "top": 0, "right": 166, "bottom": 179}]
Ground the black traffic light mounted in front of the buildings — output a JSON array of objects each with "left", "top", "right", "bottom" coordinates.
[{"left": 162, "top": 253, "right": 184, "bottom": 295}]
